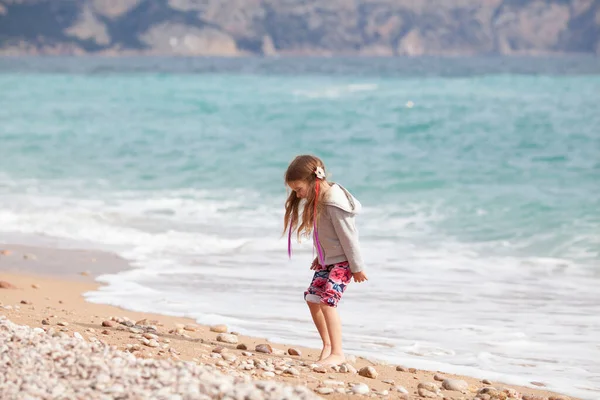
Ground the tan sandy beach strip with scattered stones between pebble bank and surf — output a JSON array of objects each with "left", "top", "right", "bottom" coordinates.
[{"left": 0, "top": 245, "right": 567, "bottom": 400}]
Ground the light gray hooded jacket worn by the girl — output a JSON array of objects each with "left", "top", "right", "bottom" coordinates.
[{"left": 317, "top": 183, "right": 365, "bottom": 272}]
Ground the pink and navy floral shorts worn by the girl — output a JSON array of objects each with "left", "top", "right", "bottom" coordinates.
[{"left": 304, "top": 261, "right": 352, "bottom": 307}]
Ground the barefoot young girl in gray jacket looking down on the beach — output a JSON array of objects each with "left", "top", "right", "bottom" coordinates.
[{"left": 284, "top": 155, "right": 367, "bottom": 365}]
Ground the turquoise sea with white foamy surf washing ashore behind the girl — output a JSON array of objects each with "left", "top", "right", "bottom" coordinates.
[{"left": 0, "top": 59, "right": 600, "bottom": 398}]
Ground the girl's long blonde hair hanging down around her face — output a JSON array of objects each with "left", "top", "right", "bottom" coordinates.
[{"left": 283, "top": 155, "right": 325, "bottom": 239}]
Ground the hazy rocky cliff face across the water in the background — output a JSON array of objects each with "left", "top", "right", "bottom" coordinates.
[{"left": 0, "top": 0, "right": 600, "bottom": 56}]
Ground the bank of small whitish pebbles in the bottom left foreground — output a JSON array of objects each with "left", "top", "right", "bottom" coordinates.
[{"left": 0, "top": 317, "right": 318, "bottom": 400}]
